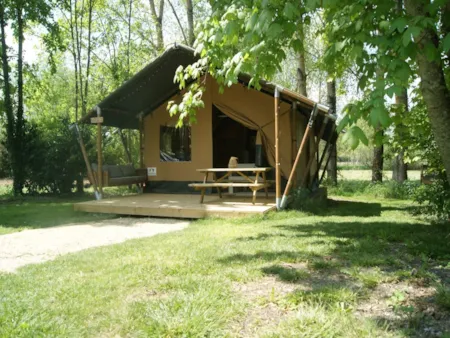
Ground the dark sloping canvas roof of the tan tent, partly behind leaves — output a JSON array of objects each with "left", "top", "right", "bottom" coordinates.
[{"left": 80, "top": 44, "right": 335, "bottom": 141}]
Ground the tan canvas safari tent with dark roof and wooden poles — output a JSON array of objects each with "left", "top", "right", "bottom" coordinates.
[{"left": 75, "top": 45, "right": 337, "bottom": 218}]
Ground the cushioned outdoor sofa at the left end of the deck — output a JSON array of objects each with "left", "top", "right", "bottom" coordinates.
[{"left": 91, "top": 163, "right": 147, "bottom": 187}]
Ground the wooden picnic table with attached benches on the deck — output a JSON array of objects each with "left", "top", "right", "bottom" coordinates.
[{"left": 189, "top": 167, "right": 272, "bottom": 204}]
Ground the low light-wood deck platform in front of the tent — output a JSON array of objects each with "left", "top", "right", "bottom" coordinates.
[{"left": 74, "top": 194, "right": 275, "bottom": 218}]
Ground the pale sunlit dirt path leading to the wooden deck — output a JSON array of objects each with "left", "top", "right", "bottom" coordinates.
[{"left": 0, "top": 218, "right": 189, "bottom": 272}]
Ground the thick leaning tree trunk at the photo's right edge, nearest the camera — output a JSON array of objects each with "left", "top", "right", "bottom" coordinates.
[{"left": 405, "top": 0, "right": 450, "bottom": 182}]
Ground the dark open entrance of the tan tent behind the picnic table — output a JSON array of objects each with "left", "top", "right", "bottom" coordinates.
[{"left": 212, "top": 105, "right": 267, "bottom": 168}]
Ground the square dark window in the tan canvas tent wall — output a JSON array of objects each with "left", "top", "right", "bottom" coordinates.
[{"left": 159, "top": 126, "right": 191, "bottom": 162}]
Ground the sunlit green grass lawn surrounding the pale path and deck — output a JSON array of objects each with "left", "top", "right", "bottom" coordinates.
[{"left": 0, "top": 194, "right": 450, "bottom": 337}]
